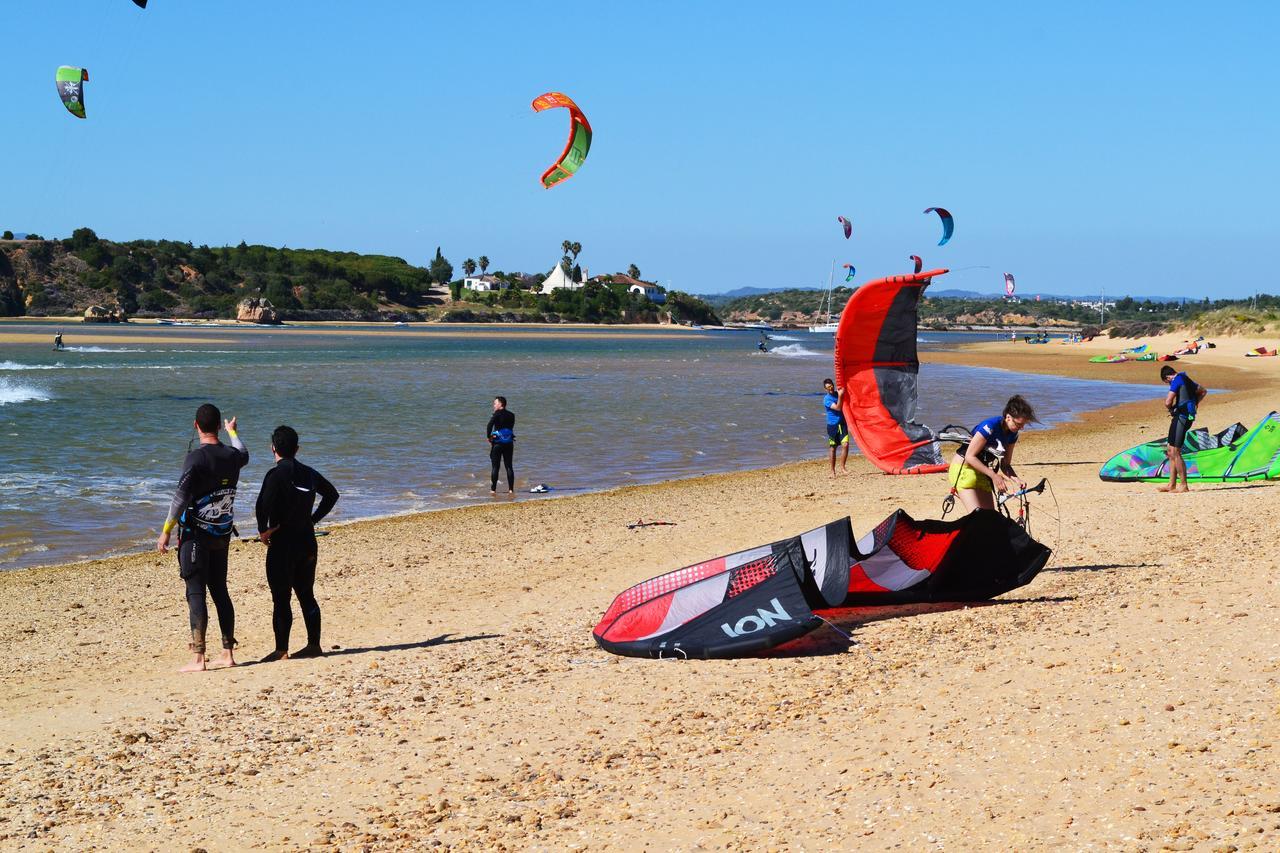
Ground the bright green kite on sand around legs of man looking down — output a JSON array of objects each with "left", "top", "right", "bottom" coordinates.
[{"left": 1098, "top": 412, "right": 1280, "bottom": 483}]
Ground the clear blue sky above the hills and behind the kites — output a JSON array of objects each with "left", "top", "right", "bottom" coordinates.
[{"left": 0, "top": 0, "right": 1280, "bottom": 298}]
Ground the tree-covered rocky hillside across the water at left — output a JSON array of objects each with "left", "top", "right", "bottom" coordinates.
[{"left": 0, "top": 228, "right": 719, "bottom": 324}]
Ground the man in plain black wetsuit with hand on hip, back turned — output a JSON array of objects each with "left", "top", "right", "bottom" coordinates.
[{"left": 257, "top": 427, "right": 338, "bottom": 663}]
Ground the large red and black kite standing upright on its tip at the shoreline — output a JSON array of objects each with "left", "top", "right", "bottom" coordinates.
[{"left": 836, "top": 269, "right": 969, "bottom": 474}]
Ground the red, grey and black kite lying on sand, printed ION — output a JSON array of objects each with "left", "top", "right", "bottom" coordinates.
[{"left": 594, "top": 510, "right": 1050, "bottom": 658}]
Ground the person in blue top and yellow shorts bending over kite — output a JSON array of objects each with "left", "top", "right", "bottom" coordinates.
[{"left": 947, "top": 394, "right": 1039, "bottom": 512}]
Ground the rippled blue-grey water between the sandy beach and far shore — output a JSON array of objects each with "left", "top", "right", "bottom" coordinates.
[{"left": 0, "top": 324, "right": 1160, "bottom": 570}]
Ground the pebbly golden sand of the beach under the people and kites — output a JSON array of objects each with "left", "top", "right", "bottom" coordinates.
[{"left": 0, "top": 330, "right": 1280, "bottom": 850}]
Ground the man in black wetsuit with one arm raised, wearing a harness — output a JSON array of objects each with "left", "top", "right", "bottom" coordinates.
[{"left": 156, "top": 403, "right": 248, "bottom": 672}]
